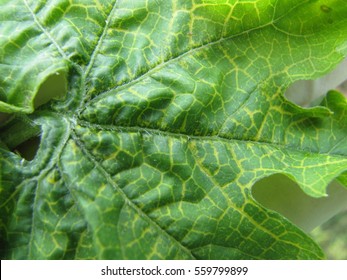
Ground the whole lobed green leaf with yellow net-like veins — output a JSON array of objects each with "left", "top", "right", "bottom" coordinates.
[{"left": 0, "top": 0, "right": 347, "bottom": 259}]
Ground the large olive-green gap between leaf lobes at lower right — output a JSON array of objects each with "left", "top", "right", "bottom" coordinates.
[{"left": 252, "top": 174, "right": 347, "bottom": 232}]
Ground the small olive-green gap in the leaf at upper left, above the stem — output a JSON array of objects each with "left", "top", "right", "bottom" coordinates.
[{"left": 34, "top": 72, "right": 67, "bottom": 108}]
